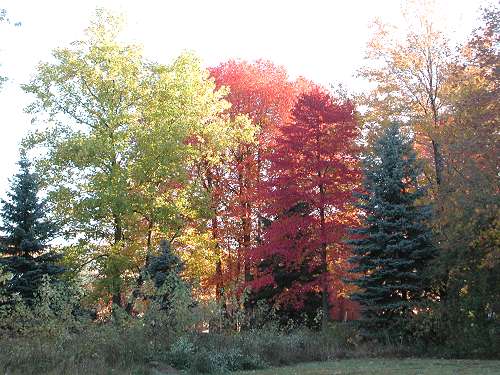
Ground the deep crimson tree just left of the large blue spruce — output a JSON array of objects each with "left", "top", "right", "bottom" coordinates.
[{"left": 250, "top": 88, "right": 360, "bottom": 323}]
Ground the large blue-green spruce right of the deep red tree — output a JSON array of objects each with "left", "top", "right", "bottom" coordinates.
[{"left": 348, "top": 124, "right": 436, "bottom": 339}]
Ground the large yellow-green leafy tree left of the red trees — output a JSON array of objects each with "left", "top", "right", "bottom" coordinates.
[{"left": 23, "top": 10, "right": 228, "bottom": 304}]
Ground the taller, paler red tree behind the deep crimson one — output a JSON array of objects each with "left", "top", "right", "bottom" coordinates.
[{"left": 210, "top": 60, "right": 297, "bottom": 302}]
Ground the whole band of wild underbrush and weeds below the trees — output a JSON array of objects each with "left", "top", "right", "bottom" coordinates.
[{"left": 0, "top": 274, "right": 492, "bottom": 375}]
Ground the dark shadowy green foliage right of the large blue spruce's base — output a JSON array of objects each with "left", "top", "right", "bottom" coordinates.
[{"left": 411, "top": 222, "right": 500, "bottom": 358}]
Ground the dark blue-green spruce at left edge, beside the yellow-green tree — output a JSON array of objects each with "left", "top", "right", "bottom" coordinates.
[{"left": 0, "top": 153, "right": 64, "bottom": 303}]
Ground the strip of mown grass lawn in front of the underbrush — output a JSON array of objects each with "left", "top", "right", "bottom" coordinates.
[{"left": 236, "top": 359, "right": 500, "bottom": 375}]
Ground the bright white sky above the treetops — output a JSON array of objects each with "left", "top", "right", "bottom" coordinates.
[{"left": 0, "top": 0, "right": 489, "bottom": 197}]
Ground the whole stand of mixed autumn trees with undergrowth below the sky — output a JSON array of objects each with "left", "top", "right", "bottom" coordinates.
[{"left": 0, "top": 3, "right": 500, "bottom": 373}]
